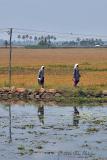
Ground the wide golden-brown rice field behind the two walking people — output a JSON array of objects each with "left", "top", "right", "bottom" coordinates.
[{"left": 0, "top": 48, "right": 107, "bottom": 89}]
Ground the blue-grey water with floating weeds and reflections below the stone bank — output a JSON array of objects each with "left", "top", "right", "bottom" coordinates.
[{"left": 0, "top": 103, "right": 107, "bottom": 160}]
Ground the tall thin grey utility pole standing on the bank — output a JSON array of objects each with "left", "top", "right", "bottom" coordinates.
[{"left": 9, "top": 28, "right": 12, "bottom": 87}]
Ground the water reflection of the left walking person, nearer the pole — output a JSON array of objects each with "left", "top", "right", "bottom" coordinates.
[{"left": 38, "top": 102, "right": 44, "bottom": 125}]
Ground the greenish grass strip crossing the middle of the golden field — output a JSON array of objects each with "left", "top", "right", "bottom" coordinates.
[{"left": 0, "top": 64, "right": 107, "bottom": 74}]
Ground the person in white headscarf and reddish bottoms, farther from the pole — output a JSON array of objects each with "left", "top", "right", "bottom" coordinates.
[{"left": 73, "top": 64, "right": 80, "bottom": 87}]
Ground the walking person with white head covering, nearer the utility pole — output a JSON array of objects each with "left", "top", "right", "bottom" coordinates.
[{"left": 38, "top": 66, "right": 45, "bottom": 88}]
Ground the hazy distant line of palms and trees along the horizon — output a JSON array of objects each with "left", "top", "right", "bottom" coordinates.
[{"left": 1, "top": 34, "right": 104, "bottom": 48}]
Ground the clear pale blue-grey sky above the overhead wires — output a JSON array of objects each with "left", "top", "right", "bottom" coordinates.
[{"left": 0, "top": 0, "right": 107, "bottom": 35}]
